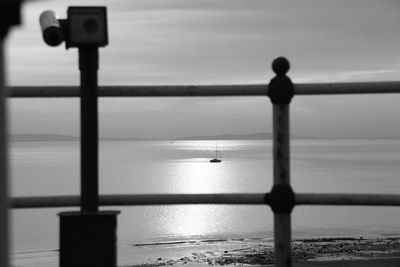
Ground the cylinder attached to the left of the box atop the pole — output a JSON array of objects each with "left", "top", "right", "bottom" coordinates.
[{"left": 39, "top": 10, "right": 64, "bottom": 46}]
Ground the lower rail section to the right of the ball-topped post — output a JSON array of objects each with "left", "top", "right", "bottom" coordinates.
[{"left": 296, "top": 193, "right": 400, "bottom": 206}]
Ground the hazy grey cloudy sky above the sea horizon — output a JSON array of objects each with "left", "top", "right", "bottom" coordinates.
[{"left": 6, "top": 0, "right": 400, "bottom": 138}]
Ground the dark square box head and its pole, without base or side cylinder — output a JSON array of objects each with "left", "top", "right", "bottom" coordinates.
[{"left": 67, "top": 7, "right": 108, "bottom": 212}]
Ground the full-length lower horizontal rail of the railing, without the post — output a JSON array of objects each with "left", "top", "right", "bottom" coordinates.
[{"left": 10, "top": 193, "right": 400, "bottom": 209}]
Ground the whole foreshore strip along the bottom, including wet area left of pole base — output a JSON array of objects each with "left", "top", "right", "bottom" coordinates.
[{"left": 12, "top": 235, "right": 400, "bottom": 267}]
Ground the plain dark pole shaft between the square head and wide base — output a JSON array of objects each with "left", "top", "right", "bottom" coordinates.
[{"left": 79, "top": 47, "right": 99, "bottom": 212}]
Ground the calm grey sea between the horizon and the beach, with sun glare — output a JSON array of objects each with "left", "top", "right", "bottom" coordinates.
[{"left": 10, "top": 139, "right": 400, "bottom": 267}]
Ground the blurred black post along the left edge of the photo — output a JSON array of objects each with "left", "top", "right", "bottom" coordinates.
[{"left": 0, "top": 0, "right": 21, "bottom": 267}]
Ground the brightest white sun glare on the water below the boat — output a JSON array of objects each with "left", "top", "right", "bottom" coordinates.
[{"left": 164, "top": 141, "right": 230, "bottom": 237}]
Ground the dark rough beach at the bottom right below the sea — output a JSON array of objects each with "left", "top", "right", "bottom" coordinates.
[{"left": 121, "top": 236, "right": 400, "bottom": 267}]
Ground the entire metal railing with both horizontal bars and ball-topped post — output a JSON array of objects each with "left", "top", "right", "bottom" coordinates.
[{"left": 9, "top": 58, "right": 400, "bottom": 267}]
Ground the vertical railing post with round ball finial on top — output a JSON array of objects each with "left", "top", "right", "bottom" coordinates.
[{"left": 268, "top": 57, "right": 295, "bottom": 267}]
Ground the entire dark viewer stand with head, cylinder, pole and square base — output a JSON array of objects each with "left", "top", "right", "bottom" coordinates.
[{"left": 40, "top": 6, "right": 119, "bottom": 267}]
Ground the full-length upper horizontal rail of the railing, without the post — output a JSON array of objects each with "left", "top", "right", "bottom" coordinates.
[{"left": 8, "top": 82, "right": 400, "bottom": 97}]
